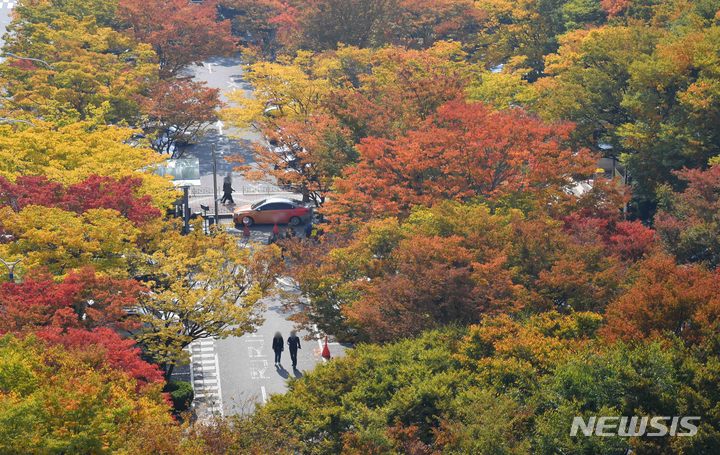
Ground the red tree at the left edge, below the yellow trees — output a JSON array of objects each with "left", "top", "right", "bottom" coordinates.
[{"left": 0, "top": 269, "right": 143, "bottom": 333}]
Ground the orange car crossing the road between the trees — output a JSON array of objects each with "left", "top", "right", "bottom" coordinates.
[{"left": 233, "top": 197, "right": 312, "bottom": 229}]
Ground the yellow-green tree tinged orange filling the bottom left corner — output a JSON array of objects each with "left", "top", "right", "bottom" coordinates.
[{"left": 0, "top": 335, "right": 179, "bottom": 453}]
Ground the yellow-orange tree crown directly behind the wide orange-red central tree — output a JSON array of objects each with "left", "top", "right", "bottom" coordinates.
[{"left": 326, "top": 41, "right": 478, "bottom": 142}]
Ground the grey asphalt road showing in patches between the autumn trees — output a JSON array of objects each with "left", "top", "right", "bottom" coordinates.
[{"left": 185, "top": 58, "right": 345, "bottom": 418}]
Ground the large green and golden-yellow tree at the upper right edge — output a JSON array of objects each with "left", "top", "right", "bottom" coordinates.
[{"left": 534, "top": 22, "right": 720, "bottom": 221}]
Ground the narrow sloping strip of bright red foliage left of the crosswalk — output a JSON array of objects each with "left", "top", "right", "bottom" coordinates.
[{"left": 35, "top": 327, "right": 163, "bottom": 386}]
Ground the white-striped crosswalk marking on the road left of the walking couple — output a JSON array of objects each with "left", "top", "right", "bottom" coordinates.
[{"left": 188, "top": 338, "right": 223, "bottom": 419}]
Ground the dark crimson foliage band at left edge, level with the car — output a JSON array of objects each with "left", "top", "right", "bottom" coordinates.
[{"left": 0, "top": 176, "right": 161, "bottom": 224}]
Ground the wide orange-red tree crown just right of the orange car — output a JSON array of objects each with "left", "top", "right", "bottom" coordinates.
[{"left": 328, "top": 101, "right": 593, "bottom": 226}]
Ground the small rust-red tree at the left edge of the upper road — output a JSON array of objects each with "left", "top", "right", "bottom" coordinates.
[{"left": 142, "top": 79, "right": 220, "bottom": 158}]
